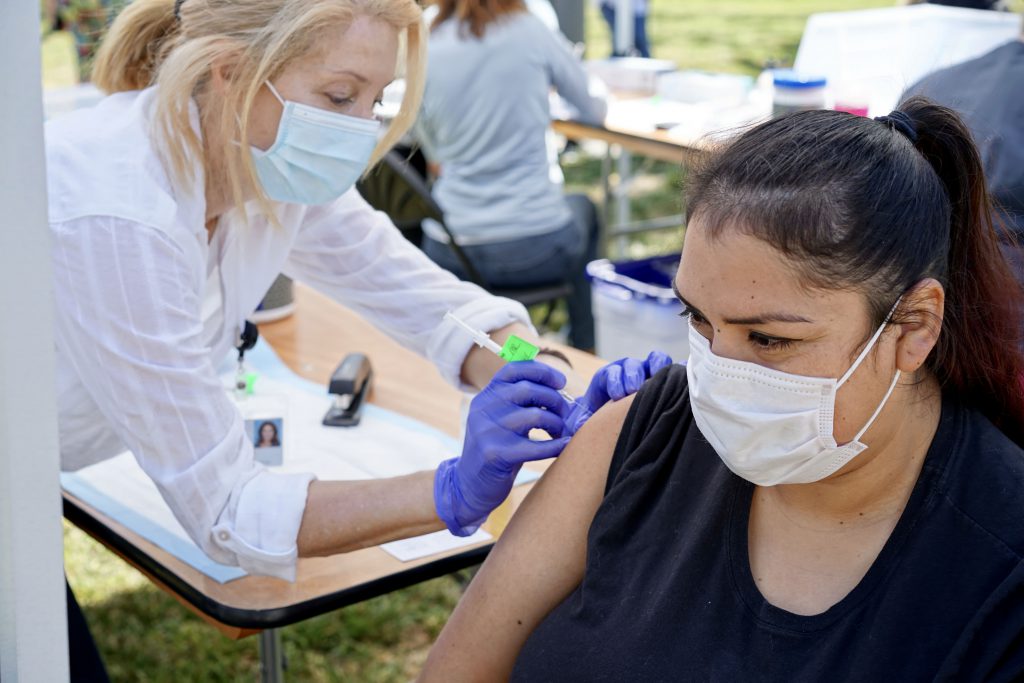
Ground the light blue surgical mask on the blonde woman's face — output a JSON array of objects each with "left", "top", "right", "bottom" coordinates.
[{"left": 252, "top": 81, "right": 381, "bottom": 204}]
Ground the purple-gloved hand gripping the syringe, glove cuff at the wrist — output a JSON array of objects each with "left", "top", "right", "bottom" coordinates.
[{"left": 434, "top": 360, "right": 570, "bottom": 536}]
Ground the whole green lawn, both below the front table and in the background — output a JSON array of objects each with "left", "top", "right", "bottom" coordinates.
[{"left": 51, "top": 0, "right": 1024, "bottom": 682}]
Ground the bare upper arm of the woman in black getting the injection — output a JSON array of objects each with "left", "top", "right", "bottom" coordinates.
[{"left": 423, "top": 396, "right": 633, "bottom": 681}]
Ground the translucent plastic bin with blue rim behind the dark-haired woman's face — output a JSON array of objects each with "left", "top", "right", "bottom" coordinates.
[{"left": 587, "top": 254, "right": 690, "bottom": 361}]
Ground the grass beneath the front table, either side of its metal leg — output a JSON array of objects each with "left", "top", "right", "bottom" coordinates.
[{"left": 65, "top": 523, "right": 466, "bottom": 683}]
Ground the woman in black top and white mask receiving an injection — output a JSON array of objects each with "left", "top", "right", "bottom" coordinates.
[{"left": 424, "top": 98, "right": 1024, "bottom": 681}]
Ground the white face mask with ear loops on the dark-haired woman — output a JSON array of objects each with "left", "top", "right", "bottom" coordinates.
[{"left": 686, "top": 302, "right": 899, "bottom": 486}]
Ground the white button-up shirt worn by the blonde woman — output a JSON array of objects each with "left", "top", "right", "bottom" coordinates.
[{"left": 46, "top": 88, "right": 528, "bottom": 580}]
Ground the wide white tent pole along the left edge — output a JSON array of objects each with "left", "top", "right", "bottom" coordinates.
[{"left": 0, "top": 0, "right": 69, "bottom": 683}]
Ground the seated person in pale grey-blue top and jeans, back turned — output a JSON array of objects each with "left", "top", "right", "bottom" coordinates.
[{"left": 414, "top": 0, "right": 606, "bottom": 349}]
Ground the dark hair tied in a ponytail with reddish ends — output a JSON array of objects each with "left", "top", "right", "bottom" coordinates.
[{"left": 687, "top": 97, "right": 1024, "bottom": 445}]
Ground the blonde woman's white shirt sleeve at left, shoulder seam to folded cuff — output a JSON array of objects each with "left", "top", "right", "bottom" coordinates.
[{"left": 51, "top": 217, "right": 313, "bottom": 581}]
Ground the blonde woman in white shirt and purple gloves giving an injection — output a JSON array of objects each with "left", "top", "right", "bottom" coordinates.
[{"left": 46, "top": 0, "right": 660, "bottom": 671}]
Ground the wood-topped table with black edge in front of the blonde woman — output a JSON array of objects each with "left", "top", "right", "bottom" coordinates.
[{"left": 65, "top": 285, "right": 601, "bottom": 680}]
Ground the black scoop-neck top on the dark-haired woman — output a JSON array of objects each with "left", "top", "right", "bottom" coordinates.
[{"left": 512, "top": 366, "right": 1024, "bottom": 682}]
